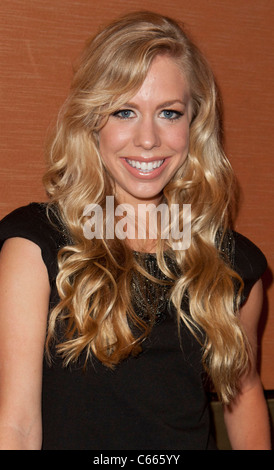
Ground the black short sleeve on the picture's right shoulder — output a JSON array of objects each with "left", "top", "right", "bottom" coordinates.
[{"left": 234, "top": 232, "right": 267, "bottom": 302}]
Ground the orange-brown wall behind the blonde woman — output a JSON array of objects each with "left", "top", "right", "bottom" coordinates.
[{"left": 0, "top": 0, "right": 274, "bottom": 389}]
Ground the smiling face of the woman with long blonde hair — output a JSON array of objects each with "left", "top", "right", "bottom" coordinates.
[{"left": 99, "top": 56, "right": 191, "bottom": 205}]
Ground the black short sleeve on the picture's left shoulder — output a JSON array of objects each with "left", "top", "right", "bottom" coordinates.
[{"left": 0, "top": 203, "right": 64, "bottom": 283}]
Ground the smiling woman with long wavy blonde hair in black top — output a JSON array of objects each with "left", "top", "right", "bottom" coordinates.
[{"left": 0, "top": 12, "right": 270, "bottom": 450}]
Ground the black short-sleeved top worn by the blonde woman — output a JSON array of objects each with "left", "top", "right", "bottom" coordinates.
[{"left": 0, "top": 203, "right": 266, "bottom": 450}]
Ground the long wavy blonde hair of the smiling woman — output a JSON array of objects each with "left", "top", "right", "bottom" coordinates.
[{"left": 44, "top": 12, "right": 249, "bottom": 403}]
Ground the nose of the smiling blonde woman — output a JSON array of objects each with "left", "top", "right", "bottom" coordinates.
[{"left": 134, "top": 117, "right": 161, "bottom": 150}]
